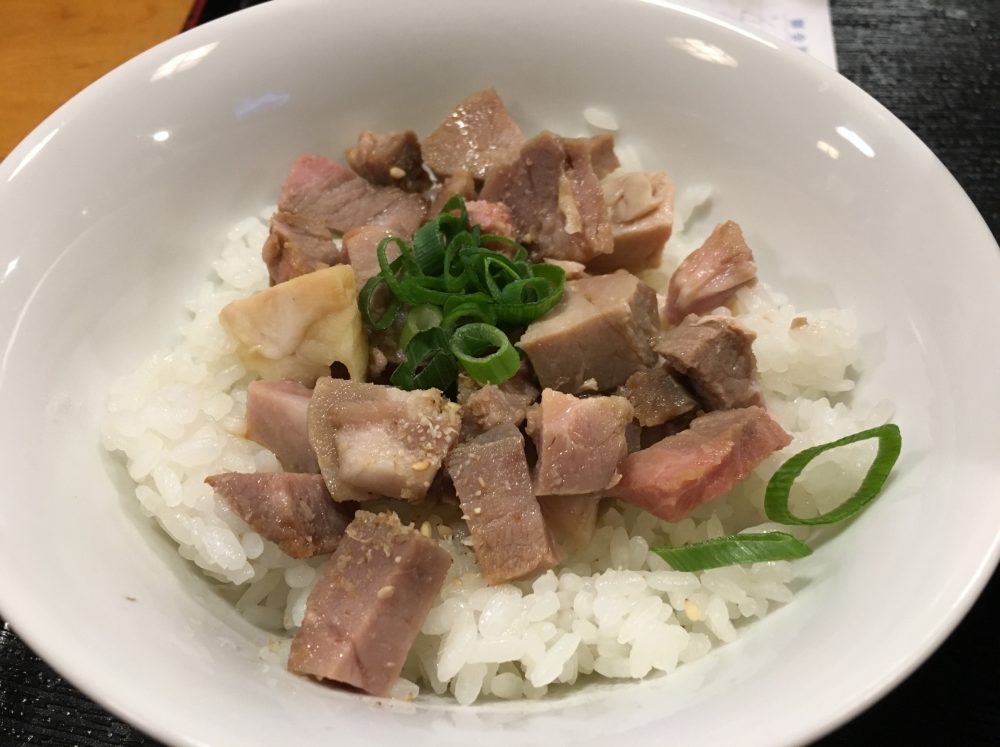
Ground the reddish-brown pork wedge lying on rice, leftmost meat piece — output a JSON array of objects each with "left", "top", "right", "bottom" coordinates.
[{"left": 205, "top": 472, "right": 354, "bottom": 558}]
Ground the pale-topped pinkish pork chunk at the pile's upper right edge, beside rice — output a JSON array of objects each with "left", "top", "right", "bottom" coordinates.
[{"left": 588, "top": 171, "right": 674, "bottom": 272}]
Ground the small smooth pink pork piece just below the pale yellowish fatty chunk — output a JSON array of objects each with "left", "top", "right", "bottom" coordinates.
[{"left": 247, "top": 381, "right": 319, "bottom": 473}]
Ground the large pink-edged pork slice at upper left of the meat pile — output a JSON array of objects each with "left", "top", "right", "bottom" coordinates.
[{"left": 263, "top": 155, "right": 427, "bottom": 285}]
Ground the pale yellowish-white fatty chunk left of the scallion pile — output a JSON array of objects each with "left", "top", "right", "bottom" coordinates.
[{"left": 219, "top": 265, "right": 368, "bottom": 386}]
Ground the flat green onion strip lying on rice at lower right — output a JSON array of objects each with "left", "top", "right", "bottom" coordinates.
[{"left": 653, "top": 532, "right": 812, "bottom": 571}]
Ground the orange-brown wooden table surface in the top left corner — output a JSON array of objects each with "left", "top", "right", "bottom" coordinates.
[{"left": 0, "top": 0, "right": 192, "bottom": 158}]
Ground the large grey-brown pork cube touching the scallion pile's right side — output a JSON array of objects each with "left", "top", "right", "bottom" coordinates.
[{"left": 517, "top": 270, "right": 659, "bottom": 393}]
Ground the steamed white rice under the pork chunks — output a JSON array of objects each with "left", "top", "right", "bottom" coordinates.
[{"left": 102, "top": 189, "right": 891, "bottom": 704}]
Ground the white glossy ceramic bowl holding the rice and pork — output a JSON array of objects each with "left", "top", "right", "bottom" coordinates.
[{"left": 0, "top": 0, "right": 1000, "bottom": 745}]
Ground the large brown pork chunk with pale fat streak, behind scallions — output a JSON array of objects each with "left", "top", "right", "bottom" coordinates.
[{"left": 479, "top": 132, "right": 617, "bottom": 263}]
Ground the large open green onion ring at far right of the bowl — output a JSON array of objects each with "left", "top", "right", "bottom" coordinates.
[{"left": 764, "top": 423, "right": 902, "bottom": 525}]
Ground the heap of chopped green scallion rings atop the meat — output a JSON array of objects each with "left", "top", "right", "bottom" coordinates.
[{"left": 358, "top": 195, "right": 566, "bottom": 389}]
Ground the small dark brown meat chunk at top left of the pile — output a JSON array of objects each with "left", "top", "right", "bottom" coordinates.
[{"left": 347, "top": 130, "right": 431, "bottom": 192}]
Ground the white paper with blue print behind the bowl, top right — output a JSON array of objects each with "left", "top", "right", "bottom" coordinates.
[{"left": 679, "top": 0, "right": 837, "bottom": 70}]
